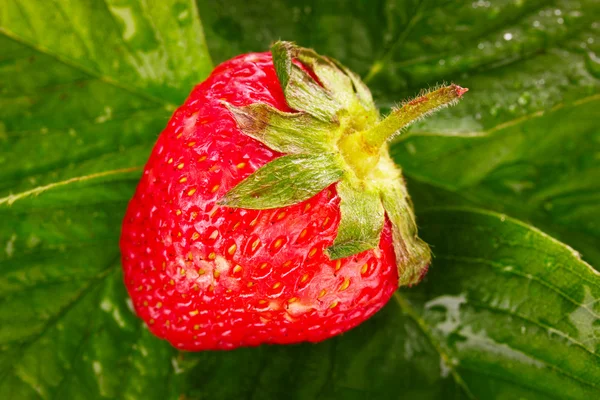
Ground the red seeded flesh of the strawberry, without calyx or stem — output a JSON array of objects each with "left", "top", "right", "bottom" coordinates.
[{"left": 121, "top": 53, "right": 398, "bottom": 350}]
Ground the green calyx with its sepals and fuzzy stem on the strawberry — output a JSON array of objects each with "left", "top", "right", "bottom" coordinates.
[{"left": 220, "top": 42, "right": 466, "bottom": 285}]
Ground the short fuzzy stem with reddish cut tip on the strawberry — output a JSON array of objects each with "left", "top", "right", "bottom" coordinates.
[{"left": 362, "top": 84, "right": 469, "bottom": 149}]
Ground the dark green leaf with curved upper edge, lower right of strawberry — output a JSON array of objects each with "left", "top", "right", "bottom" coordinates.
[{"left": 184, "top": 209, "right": 600, "bottom": 400}]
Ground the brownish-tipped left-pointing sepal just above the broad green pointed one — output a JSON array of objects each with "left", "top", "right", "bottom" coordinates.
[{"left": 225, "top": 103, "right": 336, "bottom": 154}]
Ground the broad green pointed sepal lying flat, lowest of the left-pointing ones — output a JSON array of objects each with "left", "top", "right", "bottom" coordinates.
[{"left": 219, "top": 154, "right": 344, "bottom": 210}]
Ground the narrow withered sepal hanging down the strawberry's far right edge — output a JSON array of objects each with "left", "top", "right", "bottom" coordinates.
[{"left": 380, "top": 158, "right": 431, "bottom": 286}]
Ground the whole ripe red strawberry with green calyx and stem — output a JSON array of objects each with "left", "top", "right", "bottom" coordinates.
[{"left": 121, "top": 42, "right": 466, "bottom": 350}]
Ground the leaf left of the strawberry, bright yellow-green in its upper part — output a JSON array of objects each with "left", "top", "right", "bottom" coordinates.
[{"left": 0, "top": 0, "right": 211, "bottom": 399}]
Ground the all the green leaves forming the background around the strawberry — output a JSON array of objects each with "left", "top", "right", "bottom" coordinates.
[{"left": 0, "top": 0, "right": 600, "bottom": 399}]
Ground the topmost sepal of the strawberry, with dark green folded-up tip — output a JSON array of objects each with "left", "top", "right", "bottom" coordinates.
[{"left": 271, "top": 42, "right": 342, "bottom": 122}]
